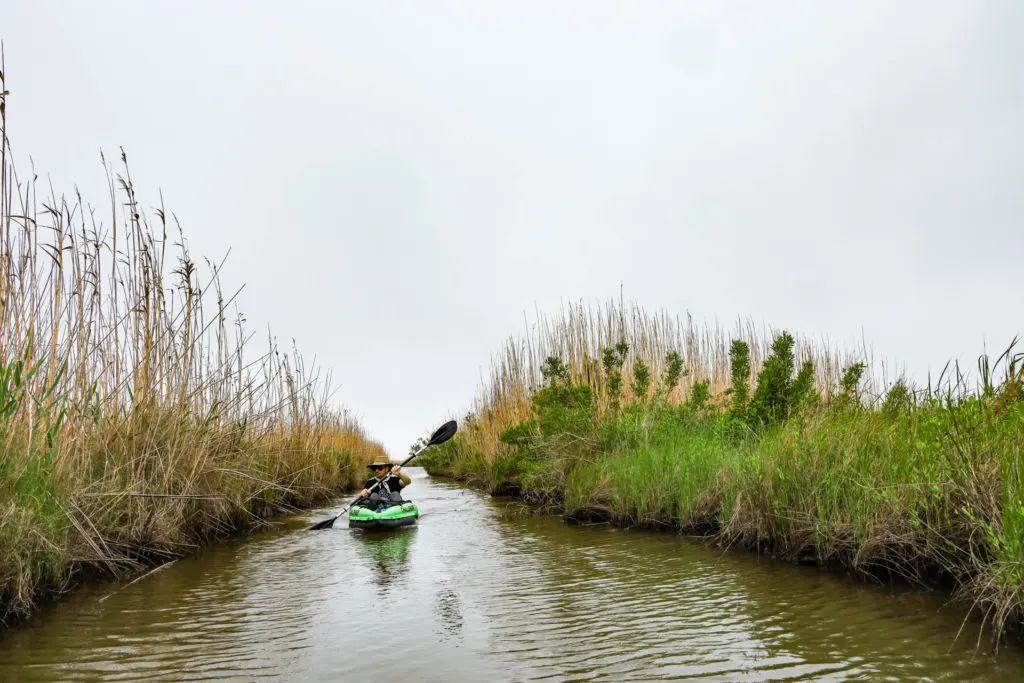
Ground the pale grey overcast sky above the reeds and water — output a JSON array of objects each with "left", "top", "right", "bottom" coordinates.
[{"left": 0, "top": 0, "right": 1024, "bottom": 457}]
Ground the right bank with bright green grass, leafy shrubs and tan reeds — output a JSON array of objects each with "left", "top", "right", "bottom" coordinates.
[{"left": 423, "top": 307, "right": 1024, "bottom": 635}]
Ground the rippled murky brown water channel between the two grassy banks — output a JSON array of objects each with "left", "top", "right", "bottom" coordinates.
[{"left": 0, "top": 468, "right": 1024, "bottom": 682}]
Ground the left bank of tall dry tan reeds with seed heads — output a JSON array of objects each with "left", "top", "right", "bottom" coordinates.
[{"left": 0, "top": 66, "right": 381, "bottom": 623}]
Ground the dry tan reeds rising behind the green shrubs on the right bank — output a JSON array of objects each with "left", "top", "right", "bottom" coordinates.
[{"left": 438, "top": 301, "right": 884, "bottom": 479}]
